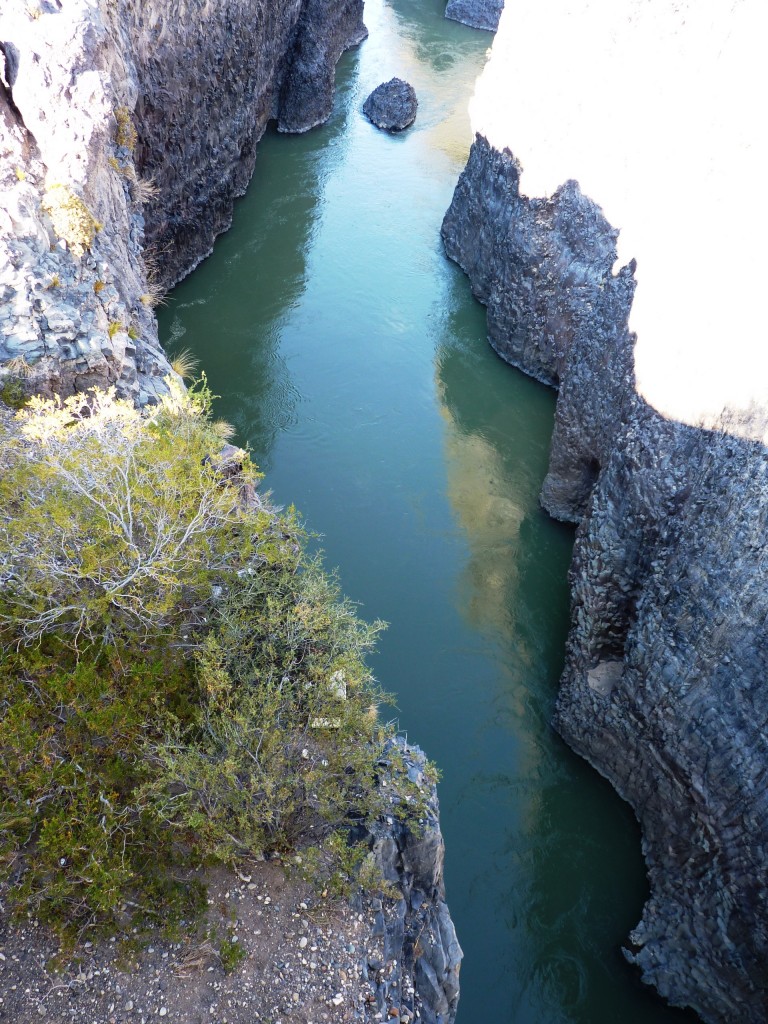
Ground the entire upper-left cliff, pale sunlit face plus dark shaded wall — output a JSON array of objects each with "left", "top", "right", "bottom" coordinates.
[{"left": 0, "top": 0, "right": 366, "bottom": 404}]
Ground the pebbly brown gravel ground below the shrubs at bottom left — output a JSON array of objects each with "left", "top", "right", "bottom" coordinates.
[{"left": 0, "top": 861, "right": 419, "bottom": 1024}]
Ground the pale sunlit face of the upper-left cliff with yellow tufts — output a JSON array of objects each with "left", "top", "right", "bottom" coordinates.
[{"left": 0, "top": 0, "right": 170, "bottom": 402}]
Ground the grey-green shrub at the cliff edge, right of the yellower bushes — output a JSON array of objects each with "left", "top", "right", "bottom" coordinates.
[{"left": 145, "top": 555, "right": 387, "bottom": 860}]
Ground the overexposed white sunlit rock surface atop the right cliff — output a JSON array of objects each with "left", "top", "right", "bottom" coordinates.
[{"left": 471, "top": 0, "right": 768, "bottom": 434}]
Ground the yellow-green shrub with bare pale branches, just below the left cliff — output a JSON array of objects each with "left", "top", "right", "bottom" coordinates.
[{"left": 0, "top": 385, "right": 257, "bottom": 646}]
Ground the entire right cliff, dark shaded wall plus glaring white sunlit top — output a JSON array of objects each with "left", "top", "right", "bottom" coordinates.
[{"left": 443, "top": 0, "right": 768, "bottom": 1024}]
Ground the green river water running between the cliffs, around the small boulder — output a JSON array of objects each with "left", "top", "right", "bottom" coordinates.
[{"left": 160, "top": 0, "right": 692, "bottom": 1024}]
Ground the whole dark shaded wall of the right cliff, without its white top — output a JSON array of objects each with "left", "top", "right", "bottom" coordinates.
[{"left": 442, "top": 4, "right": 768, "bottom": 1024}]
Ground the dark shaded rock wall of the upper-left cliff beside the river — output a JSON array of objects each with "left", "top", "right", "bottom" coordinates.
[{"left": 128, "top": 0, "right": 367, "bottom": 287}]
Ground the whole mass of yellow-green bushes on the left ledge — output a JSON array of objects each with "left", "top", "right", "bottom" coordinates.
[{"left": 0, "top": 381, "right": 397, "bottom": 934}]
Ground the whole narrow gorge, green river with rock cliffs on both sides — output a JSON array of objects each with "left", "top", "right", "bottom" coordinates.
[{"left": 0, "top": 0, "right": 768, "bottom": 1024}]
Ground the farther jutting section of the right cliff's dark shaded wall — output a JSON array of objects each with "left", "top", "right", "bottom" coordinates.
[{"left": 442, "top": 135, "right": 634, "bottom": 522}]
